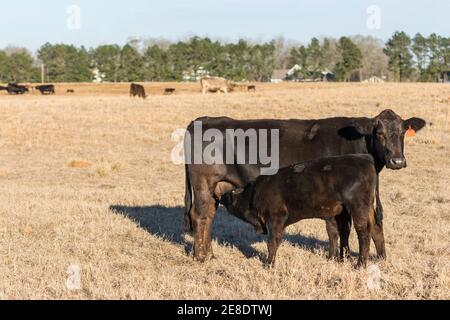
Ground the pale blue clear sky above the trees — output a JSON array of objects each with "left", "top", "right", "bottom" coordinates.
[{"left": 0, "top": 0, "right": 450, "bottom": 51}]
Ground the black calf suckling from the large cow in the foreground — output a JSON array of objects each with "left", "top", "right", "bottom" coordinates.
[{"left": 220, "top": 154, "right": 386, "bottom": 267}]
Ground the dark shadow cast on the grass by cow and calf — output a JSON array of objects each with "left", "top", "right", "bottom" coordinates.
[{"left": 110, "top": 205, "right": 334, "bottom": 260}]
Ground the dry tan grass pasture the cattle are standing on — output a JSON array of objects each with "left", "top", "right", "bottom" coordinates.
[{"left": 0, "top": 80, "right": 450, "bottom": 299}]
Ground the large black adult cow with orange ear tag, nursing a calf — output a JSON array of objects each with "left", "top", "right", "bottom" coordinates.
[{"left": 184, "top": 110, "right": 426, "bottom": 261}]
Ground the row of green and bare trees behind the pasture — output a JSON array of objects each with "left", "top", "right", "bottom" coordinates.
[{"left": 0, "top": 32, "right": 450, "bottom": 83}]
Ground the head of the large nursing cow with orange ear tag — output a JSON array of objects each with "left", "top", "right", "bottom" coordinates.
[{"left": 355, "top": 110, "right": 426, "bottom": 170}]
